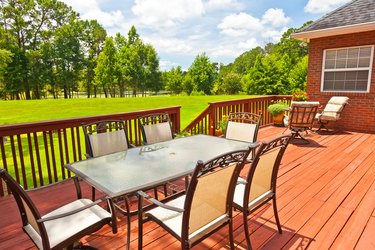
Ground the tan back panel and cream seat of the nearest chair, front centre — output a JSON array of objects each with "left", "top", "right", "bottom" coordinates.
[{"left": 146, "top": 164, "right": 236, "bottom": 244}]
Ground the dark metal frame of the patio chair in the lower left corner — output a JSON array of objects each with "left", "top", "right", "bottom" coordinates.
[{"left": 0, "top": 169, "right": 117, "bottom": 249}]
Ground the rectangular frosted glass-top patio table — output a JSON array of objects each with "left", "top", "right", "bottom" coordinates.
[{"left": 64, "top": 135, "right": 257, "bottom": 247}]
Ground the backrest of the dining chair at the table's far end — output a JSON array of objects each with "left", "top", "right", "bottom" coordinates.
[{"left": 225, "top": 112, "right": 262, "bottom": 142}]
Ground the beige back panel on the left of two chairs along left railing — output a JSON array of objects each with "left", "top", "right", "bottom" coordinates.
[{"left": 88, "top": 130, "right": 128, "bottom": 157}]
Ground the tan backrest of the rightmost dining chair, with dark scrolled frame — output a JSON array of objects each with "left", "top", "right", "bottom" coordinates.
[{"left": 244, "top": 135, "right": 292, "bottom": 207}]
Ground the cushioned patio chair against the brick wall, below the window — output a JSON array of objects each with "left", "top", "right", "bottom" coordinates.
[{"left": 315, "top": 96, "right": 349, "bottom": 132}]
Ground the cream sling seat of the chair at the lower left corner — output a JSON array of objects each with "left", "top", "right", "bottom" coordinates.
[{"left": 24, "top": 199, "right": 111, "bottom": 249}]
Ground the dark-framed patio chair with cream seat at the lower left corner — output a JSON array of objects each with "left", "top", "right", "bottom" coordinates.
[{"left": 0, "top": 169, "right": 117, "bottom": 249}]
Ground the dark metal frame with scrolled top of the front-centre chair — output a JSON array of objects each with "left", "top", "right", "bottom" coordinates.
[{"left": 138, "top": 148, "right": 252, "bottom": 249}]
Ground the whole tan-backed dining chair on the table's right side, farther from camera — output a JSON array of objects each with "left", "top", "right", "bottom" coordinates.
[{"left": 233, "top": 135, "right": 292, "bottom": 249}]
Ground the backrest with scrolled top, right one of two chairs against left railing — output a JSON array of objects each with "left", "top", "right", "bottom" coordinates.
[{"left": 138, "top": 113, "right": 173, "bottom": 144}]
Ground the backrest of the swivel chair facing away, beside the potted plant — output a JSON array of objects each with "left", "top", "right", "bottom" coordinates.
[{"left": 288, "top": 102, "right": 319, "bottom": 129}]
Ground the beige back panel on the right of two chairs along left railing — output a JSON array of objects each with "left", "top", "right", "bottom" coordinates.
[{"left": 143, "top": 122, "right": 173, "bottom": 144}]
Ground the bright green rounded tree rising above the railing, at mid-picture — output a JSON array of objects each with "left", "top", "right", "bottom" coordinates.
[{"left": 188, "top": 53, "right": 216, "bottom": 95}]
